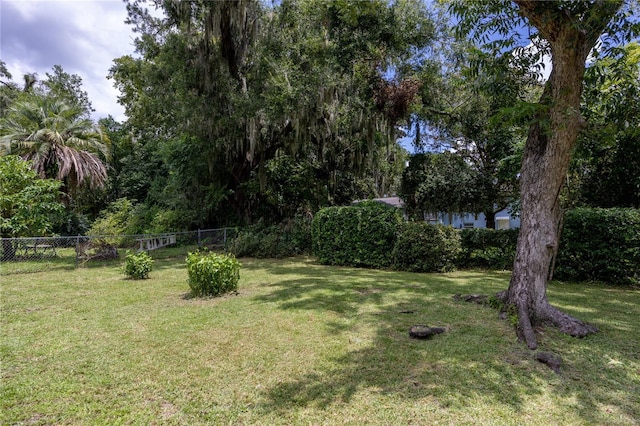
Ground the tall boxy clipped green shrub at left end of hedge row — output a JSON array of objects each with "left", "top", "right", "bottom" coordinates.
[{"left": 311, "top": 201, "right": 402, "bottom": 268}]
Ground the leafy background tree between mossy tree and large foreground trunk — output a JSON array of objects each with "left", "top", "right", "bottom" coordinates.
[{"left": 403, "top": 15, "right": 540, "bottom": 228}]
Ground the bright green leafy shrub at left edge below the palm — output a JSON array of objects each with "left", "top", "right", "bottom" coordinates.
[{"left": 0, "top": 155, "right": 64, "bottom": 237}]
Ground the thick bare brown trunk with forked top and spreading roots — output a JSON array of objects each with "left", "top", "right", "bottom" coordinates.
[{"left": 502, "top": 0, "right": 615, "bottom": 349}]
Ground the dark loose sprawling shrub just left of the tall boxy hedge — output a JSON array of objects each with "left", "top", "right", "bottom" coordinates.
[{"left": 227, "top": 216, "right": 311, "bottom": 258}]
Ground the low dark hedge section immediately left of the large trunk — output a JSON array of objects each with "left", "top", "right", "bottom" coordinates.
[{"left": 457, "top": 228, "right": 519, "bottom": 269}]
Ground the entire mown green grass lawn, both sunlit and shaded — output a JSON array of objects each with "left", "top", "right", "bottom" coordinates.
[{"left": 0, "top": 249, "right": 640, "bottom": 425}]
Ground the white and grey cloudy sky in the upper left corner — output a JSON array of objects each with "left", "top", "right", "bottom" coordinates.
[{"left": 0, "top": 0, "right": 139, "bottom": 120}]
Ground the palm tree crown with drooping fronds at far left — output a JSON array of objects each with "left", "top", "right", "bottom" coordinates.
[{"left": 0, "top": 96, "right": 109, "bottom": 190}]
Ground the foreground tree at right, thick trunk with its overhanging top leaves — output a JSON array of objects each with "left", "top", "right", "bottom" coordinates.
[{"left": 454, "top": 0, "right": 630, "bottom": 349}]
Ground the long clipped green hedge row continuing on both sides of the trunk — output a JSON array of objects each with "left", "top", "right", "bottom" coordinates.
[{"left": 312, "top": 204, "right": 640, "bottom": 285}]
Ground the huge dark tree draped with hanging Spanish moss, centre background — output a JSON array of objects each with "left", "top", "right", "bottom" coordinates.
[{"left": 111, "top": 0, "right": 430, "bottom": 224}]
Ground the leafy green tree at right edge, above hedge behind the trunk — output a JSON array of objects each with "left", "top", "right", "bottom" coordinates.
[{"left": 568, "top": 43, "right": 640, "bottom": 208}]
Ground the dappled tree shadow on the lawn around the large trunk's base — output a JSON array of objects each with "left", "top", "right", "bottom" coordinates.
[{"left": 249, "top": 261, "right": 640, "bottom": 424}]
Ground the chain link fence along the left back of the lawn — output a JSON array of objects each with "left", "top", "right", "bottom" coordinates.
[{"left": 0, "top": 228, "right": 238, "bottom": 275}]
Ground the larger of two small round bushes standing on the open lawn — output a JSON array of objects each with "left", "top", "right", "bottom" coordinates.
[{"left": 187, "top": 251, "right": 240, "bottom": 297}]
